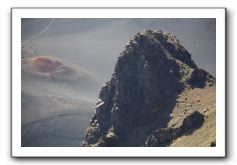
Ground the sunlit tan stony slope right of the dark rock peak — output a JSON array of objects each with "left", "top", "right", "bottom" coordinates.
[{"left": 168, "top": 84, "right": 216, "bottom": 147}]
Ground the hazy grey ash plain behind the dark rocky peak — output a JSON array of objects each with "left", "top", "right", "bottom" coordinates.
[{"left": 21, "top": 18, "right": 216, "bottom": 147}]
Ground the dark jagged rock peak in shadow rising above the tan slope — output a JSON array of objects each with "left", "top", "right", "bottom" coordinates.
[{"left": 82, "top": 30, "right": 215, "bottom": 146}]
